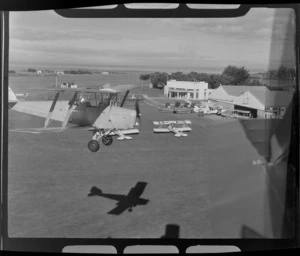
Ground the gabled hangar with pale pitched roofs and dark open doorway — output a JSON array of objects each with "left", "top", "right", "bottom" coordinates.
[{"left": 209, "top": 85, "right": 293, "bottom": 118}]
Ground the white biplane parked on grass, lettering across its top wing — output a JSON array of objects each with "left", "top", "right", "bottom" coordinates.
[{"left": 153, "top": 120, "right": 192, "bottom": 137}]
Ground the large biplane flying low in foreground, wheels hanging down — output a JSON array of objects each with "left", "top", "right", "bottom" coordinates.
[{"left": 10, "top": 85, "right": 140, "bottom": 152}]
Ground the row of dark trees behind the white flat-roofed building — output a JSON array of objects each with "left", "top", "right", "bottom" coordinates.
[{"left": 140, "top": 65, "right": 254, "bottom": 89}]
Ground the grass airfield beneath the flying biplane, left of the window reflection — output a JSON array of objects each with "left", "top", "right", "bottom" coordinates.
[{"left": 8, "top": 103, "right": 223, "bottom": 238}]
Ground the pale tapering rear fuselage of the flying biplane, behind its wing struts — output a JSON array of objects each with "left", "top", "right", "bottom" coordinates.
[{"left": 11, "top": 101, "right": 69, "bottom": 122}]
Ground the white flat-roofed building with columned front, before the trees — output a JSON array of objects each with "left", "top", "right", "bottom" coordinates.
[{"left": 164, "top": 80, "right": 209, "bottom": 100}]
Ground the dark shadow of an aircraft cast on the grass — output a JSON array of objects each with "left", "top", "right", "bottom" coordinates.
[{"left": 88, "top": 182, "right": 149, "bottom": 215}]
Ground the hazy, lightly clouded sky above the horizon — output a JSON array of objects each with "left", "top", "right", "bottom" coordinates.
[{"left": 9, "top": 4, "right": 295, "bottom": 73}]
